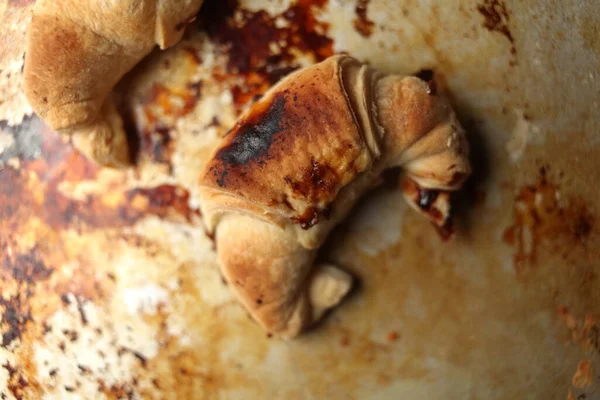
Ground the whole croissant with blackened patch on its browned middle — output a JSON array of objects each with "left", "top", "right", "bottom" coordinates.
[{"left": 200, "top": 56, "right": 470, "bottom": 338}]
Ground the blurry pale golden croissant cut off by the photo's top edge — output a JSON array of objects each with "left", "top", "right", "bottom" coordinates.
[{"left": 24, "top": 0, "right": 202, "bottom": 166}]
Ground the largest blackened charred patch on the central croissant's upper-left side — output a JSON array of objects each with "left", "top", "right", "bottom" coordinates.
[{"left": 213, "top": 94, "right": 286, "bottom": 186}]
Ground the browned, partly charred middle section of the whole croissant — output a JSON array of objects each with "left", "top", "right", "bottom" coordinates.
[{"left": 200, "top": 57, "right": 372, "bottom": 222}]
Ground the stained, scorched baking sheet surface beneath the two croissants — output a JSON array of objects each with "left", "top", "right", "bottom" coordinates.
[{"left": 0, "top": 0, "right": 600, "bottom": 399}]
